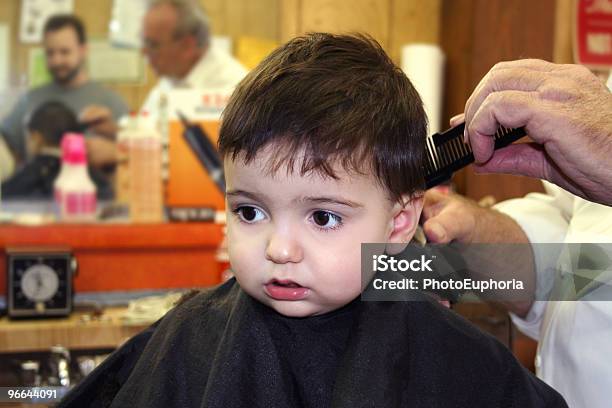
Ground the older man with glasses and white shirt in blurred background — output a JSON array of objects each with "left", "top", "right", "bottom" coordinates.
[{"left": 142, "top": 0, "right": 247, "bottom": 116}]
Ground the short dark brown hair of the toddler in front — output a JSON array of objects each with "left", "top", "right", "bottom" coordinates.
[{"left": 219, "top": 33, "right": 427, "bottom": 200}]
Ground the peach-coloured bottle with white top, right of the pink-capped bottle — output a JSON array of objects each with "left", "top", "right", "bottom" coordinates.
[{"left": 128, "top": 112, "right": 164, "bottom": 223}]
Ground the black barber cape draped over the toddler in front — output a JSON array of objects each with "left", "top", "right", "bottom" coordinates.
[{"left": 59, "top": 279, "right": 567, "bottom": 408}]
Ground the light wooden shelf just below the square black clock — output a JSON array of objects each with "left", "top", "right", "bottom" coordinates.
[{"left": 0, "top": 307, "right": 148, "bottom": 353}]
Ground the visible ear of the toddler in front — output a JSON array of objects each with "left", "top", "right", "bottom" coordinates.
[{"left": 386, "top": 194, "right": 423, "bottom": 255}]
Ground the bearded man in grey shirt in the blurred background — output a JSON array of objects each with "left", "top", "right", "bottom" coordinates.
[{"left": 0, "top": 15, "right": 128, "bottom": 177}]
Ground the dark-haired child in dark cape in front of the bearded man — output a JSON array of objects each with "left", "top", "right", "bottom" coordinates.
[{"left": 2, "top": 101, "right": 113, "bottom": 200}]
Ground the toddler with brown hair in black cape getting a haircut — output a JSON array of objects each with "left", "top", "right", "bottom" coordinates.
[{"left": 60, "top": 34, "right": 565, "bottom": 407}]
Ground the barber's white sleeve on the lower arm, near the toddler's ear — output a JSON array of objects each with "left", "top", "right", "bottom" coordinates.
[{"left": 494, "top": 183, "right": 574, "bottom": 340}]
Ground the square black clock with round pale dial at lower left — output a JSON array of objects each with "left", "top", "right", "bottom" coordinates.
[{"left": 8, "top": 254, "right": 72, "bottom": 317}]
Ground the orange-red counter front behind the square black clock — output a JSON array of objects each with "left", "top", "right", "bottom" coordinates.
[{"left": 0, "top": 223, "right": 222, "bottom": 294}]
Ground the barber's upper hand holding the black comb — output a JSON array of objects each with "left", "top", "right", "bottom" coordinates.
[{"left": 462, "top": 60, "right": 612, "bottom": 205}]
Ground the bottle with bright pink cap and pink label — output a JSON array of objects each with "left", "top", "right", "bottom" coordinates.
[{"left": 53, "top": 133, "right": 97, "bottom": 222}]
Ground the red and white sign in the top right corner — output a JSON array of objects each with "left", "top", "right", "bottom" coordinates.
[{"left": 574, "top": 0, "right": 612, "bottom": 68}]
